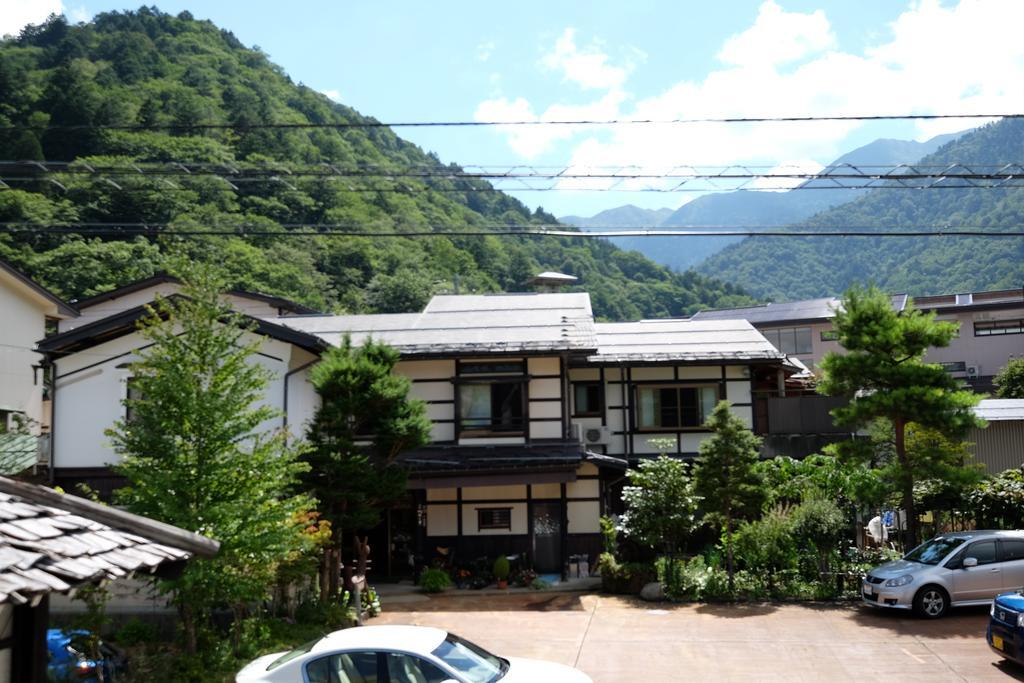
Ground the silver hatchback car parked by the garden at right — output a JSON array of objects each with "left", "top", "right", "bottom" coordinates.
[{"left": 861, "top": 530, "right": 1024, "bottom": 618}]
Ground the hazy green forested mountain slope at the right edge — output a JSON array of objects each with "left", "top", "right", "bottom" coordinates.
[{"left": 700, "top": 119, "right": 1024, "bottom": 300}]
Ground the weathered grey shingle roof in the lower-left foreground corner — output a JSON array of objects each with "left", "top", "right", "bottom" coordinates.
[{"left": 0, "top": 477, "right": 218, "bottom": 604}]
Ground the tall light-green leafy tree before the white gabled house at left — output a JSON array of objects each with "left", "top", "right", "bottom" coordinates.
[{"left": 106, "top": 267, "right": 312, "bottom": 654}]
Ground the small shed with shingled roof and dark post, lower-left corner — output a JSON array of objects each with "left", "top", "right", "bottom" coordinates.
[{"left": 0, "top": 477, "right": 219, "bottom": 683}]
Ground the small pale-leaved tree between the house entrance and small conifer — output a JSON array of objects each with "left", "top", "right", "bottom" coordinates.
[{"left": 618, "top": 455, "right": 699, "bottom": 557}]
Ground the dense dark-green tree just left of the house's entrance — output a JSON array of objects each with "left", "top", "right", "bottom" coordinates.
[{"left": 303, "top": 336, "right": 431, "bottom": 599}]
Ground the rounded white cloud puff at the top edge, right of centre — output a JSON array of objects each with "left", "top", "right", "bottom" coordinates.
[{"left": 718, "top": 0, "right": 836, "bottom": 67}]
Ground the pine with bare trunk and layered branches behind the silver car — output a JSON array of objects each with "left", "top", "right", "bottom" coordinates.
[{"left": 818, "top": 287, "right": 981, "bottom": 545}]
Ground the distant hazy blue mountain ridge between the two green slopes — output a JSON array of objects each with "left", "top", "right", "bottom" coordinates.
[{"left": 560, "top": 133, "right": 963, "bottom": 270}]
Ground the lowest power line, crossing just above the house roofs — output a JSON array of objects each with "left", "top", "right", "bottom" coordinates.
[{"left": 0, "top": 221, "right": 1024, "bottom": 239}]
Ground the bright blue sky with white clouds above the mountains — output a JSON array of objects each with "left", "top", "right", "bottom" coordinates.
[{"left": 0, "top": 0, "right": 1024, "bottom": 215}]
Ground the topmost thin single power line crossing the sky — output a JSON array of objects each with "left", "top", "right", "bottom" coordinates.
[{"left": 0, "top": 113, "right": 1024, "bottom": 131}]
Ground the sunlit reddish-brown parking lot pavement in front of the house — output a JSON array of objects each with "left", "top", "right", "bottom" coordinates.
[{"left": 371, "top": 592, "right": 1024, "bottom": 683}]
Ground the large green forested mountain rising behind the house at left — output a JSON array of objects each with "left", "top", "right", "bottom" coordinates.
[{"left": 0, "top": 8, "right": 750, "bottom": 319}]
